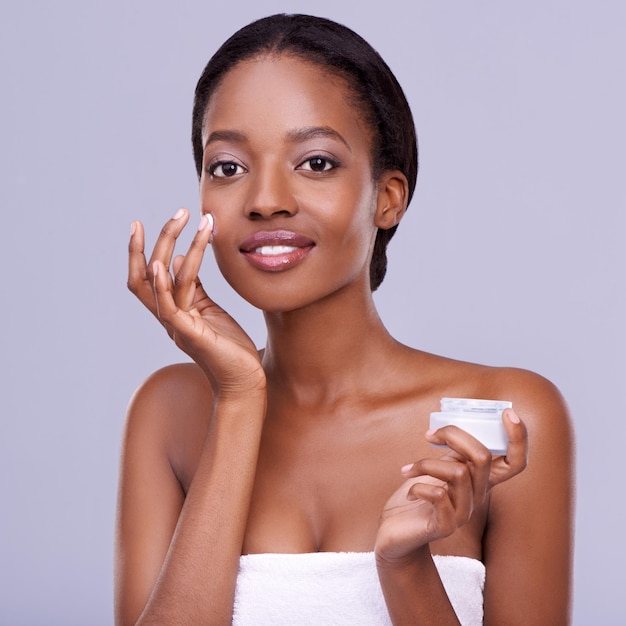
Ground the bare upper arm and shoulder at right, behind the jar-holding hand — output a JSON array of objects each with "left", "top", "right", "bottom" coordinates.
[{"left": 483, "top": 372, "right": 574, "bottom": 626}]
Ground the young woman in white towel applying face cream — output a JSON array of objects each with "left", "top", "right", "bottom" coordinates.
[{"left": 116, "top": 15, "right": 572, "bottom": 626}]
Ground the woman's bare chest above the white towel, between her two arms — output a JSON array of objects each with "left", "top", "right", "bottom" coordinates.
[{"left": 243, "top": 398, "right": 484, "bottom": 557}]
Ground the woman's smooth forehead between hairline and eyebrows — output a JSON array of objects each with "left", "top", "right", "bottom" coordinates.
[{"left": 202, "top": 54, "right": 371, "bottom": 149}]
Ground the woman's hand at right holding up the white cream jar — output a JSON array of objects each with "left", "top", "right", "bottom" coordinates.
[{"left": 375, "top": 409, "right": 528, "bottom": 563}]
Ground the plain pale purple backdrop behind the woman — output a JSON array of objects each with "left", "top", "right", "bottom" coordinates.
[{"left": 0, "top": 0, "right": 626, "bottom": 626}]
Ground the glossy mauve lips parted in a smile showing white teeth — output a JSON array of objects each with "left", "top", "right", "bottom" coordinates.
[{"left": 239, "top": 230, "right": 315, "bottom": 272}]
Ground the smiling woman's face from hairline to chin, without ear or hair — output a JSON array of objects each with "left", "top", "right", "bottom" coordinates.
[{"left": 200, "top": 56, "right": 378, "bottom": 311}]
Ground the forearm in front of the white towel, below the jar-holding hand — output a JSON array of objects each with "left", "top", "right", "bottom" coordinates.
[{"left": 376, "top": 545, "right": 460, "bottom": 626}]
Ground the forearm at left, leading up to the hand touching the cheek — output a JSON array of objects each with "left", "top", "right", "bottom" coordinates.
[{"left": 137, "top": 394, "right": 265, "bottom": 625}]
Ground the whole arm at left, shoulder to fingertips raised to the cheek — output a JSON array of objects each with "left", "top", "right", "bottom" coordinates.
[{"left": 116, "top": 211, "right": 266, "bottom": 624}]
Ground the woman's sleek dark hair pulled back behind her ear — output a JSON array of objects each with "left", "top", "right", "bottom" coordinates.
[{"left": 191, "top": 14, "right": 417, "bottom": 291}]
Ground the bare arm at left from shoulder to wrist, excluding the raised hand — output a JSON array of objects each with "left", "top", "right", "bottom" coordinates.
[{"left": 116, "top": 368, "right": 264, "bottom": 624}]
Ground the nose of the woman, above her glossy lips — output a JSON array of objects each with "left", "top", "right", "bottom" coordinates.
[{"left": 245, "top": 164, "right": 298, "bottom": 219}]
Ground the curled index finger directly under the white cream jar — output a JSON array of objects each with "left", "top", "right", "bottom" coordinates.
[{"left": 426, "top": 426, "right": 493, "bottom": 502}]
